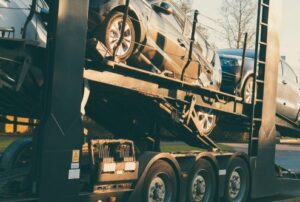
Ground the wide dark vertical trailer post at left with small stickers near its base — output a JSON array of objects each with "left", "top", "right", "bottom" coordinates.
[{"left": 32, "top": 0, "right": 88, "bottom": 202}]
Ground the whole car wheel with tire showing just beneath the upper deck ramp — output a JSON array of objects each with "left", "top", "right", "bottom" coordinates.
[{"left": 198, "top": 108, "right": 218, "bottom": 136}]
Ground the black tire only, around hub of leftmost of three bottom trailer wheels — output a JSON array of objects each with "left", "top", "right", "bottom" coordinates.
[{"left": 143, "top": 160, "right": 178, "bottom": 202}]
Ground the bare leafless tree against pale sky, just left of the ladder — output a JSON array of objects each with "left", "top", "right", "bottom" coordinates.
[{"left": 220, "top": 0, "right": 257, "bottom": 49}]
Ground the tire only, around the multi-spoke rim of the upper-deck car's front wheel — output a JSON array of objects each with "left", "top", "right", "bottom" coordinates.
[{"left": 101, "top": 11, "right": 136, "bottom": 62}]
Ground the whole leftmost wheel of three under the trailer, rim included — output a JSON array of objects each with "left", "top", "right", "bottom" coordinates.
[{"left": 143, "top": 160, "right": 177, "bottom": 202}]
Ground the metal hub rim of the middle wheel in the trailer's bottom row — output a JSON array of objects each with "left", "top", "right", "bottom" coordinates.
[{"left": 192, "top": 173, "right": 206, "bottom": 202}]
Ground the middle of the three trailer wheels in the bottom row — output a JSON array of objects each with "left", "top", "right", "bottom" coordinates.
[{"left": 187, "top": 159, "right": 216, "bottom": 202}]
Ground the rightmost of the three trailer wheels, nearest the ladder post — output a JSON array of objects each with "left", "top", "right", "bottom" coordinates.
[{"left": 224, "top": 157, "right": 250, "bottom": 202}]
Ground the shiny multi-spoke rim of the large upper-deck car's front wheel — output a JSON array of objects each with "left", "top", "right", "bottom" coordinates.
[{"left": 108, "top": 19, "right": 132, "bottom": 57}]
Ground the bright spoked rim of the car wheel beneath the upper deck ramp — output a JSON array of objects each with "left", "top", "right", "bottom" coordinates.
[{"left": 198, "top": 111, "right": 216, "bottom": 134}]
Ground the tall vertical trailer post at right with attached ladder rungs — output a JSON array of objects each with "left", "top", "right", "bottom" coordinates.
[{"left": 249, "top": 0, "right": 281, "bottom": 198}]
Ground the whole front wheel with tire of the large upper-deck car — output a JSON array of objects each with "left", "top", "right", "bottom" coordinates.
[{"left": 102, "top": 11, "right": 136, "bottom": 62}]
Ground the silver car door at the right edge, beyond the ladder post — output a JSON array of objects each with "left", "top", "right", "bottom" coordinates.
[{"left": 281, "top": 61, "right": 300, "bottom": 121}]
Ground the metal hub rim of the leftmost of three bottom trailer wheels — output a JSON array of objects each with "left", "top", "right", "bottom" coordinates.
[{"left": 148, "top": 177, "right": 166, "bottom": 202}]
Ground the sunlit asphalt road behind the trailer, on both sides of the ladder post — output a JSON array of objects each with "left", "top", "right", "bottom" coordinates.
[{"left": 224, "top": 143, "right": 300, "bottom": 173}]
